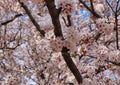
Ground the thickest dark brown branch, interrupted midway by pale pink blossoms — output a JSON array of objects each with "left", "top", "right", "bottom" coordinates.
[{"left": 45, "top": 0, "right": 82, "bottom": 84}]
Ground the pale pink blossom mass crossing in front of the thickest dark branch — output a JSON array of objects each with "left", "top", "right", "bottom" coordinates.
[{"left": 46, "top": 27, "right": 80, "bottom": 53}]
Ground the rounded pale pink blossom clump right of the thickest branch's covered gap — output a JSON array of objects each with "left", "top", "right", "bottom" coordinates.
[{"left": 63, "top": 27, "right": 80, "bottom": 53}]
